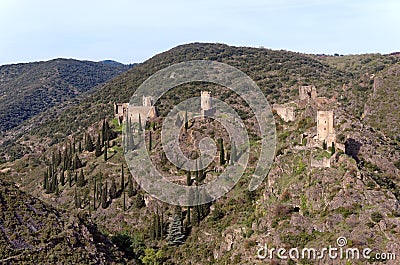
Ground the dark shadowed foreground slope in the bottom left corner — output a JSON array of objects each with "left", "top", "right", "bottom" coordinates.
[{"left": 0, "top": 179, "right": 123, "bottom": 264}]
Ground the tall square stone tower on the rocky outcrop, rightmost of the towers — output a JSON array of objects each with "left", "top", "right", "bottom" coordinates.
[{"left": 317, "top": 110, "right": 336, "bottom": 146}]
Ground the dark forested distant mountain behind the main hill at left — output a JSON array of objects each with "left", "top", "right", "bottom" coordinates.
[{"left": 0, "top": 59, "right": 131, "bottom": 132}]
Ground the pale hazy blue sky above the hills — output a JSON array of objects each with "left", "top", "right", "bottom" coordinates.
[{"left": 0, "top": 0, "right": 400, "bottom": 64}]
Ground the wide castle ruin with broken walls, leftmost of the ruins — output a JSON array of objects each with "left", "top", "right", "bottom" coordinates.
[{"left": 114, "top": 96, "right": 158, "bottom": 126}]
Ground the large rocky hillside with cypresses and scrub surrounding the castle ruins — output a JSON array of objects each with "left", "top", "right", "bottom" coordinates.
[{"left": 0, "top": 43, "right": 400, "bottom": 264}]
